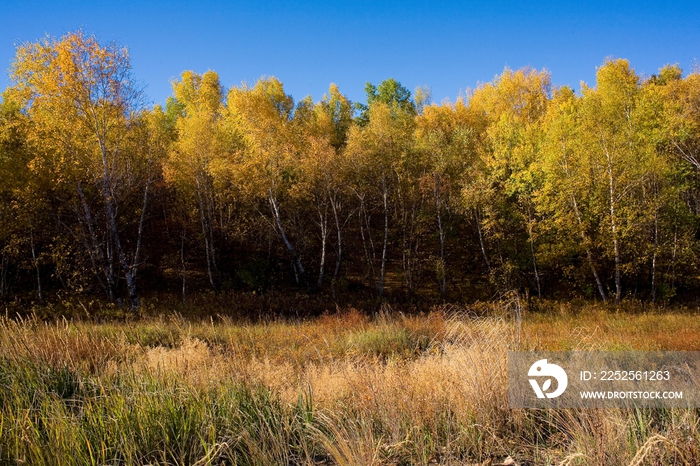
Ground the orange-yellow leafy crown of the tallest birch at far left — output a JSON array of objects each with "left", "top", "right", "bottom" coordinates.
[{"left": 12, "top": 31, "right": 141, "bottom": 183}]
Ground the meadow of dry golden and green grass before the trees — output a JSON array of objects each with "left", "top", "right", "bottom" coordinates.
[{"left": 0, "top": 299, "right": 700, "bottom": 465}]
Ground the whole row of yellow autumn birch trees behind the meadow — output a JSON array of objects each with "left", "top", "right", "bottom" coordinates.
[{"left": 0, "top": 31, "right": 700, "bottom": 308}]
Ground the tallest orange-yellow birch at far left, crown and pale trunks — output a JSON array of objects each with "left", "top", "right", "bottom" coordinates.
[{"left": 11, "top": 31, "right": 150, "bottom": 309}]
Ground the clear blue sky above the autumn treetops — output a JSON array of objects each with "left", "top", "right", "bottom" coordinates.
[{"left": 0, "top": 0, "right": 700, "bottom": 103}]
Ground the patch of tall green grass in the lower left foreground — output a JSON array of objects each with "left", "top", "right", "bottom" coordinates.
[{"left": 0, "top": 359, "right": 318, "bottom": 466}]
